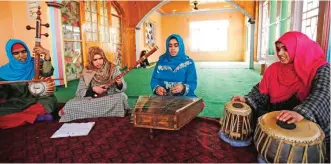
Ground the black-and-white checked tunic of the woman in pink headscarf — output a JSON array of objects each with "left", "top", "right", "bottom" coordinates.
[{"left": 245, "top": 64, "right": 330, "bottom": 152}]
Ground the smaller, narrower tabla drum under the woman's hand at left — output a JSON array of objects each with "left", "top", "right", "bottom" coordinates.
[{"left": 220, "top": 102, "right": 253, "bottom": 140}]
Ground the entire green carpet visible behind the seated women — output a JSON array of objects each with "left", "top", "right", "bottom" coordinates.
[{"left": 55, "top": 64, "right": 261, "bottom": 118}]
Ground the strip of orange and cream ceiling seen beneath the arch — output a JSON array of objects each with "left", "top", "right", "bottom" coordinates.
[{"left": 157, "top": 0, "right": 233, "bottom": 14}]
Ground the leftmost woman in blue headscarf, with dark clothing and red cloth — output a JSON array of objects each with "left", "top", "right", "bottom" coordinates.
[{"left": 0, "top": 39, "right": 57, "bottom": 128}]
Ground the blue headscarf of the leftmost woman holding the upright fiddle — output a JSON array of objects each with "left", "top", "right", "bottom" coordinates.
[{"left": 0, "top": 39, "right": 34, "bottom": 81}]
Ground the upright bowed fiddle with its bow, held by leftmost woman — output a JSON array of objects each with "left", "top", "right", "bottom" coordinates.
[{"left": 0, "top": 6, "right": 63, "bottom": 96}]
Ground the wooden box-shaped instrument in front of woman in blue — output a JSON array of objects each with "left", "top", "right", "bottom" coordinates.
[{"left": 133, "top": 95, "right": 204, "bottom": 131}]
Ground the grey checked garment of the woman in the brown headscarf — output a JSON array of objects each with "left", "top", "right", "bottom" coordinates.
[{"left": 60, "top": 67, "right": 129, "bottom": 122}]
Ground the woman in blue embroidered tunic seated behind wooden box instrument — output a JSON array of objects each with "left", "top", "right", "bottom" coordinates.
[{"left": 151, "top": 34, "right": 197, "bottom": 97}]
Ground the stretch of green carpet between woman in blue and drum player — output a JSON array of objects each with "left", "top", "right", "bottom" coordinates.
[{"left": 195, "top": 69, "right": 261, "bottom": 117}]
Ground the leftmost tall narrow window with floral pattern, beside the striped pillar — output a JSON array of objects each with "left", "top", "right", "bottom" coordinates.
[{"left": 61, "top": 1, "right": 83, "bottom": 81}]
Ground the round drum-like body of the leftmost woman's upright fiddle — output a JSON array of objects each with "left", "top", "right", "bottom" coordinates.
[{"left": 28, "top": 77, "right": 55, "bottom": 96}]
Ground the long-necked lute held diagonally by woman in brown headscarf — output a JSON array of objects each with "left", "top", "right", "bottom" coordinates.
[{"left": 92, "top": 46, "right": 159, "bottom": 98}]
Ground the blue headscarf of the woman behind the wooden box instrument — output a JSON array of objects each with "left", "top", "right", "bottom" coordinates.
[{"left": 160, "top": 34, "right": 188, "bottom": 66}]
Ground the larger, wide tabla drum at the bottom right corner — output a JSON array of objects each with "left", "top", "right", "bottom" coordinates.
[{"left": 254, "top": 111, "right": 326, "bottom": 163}]
